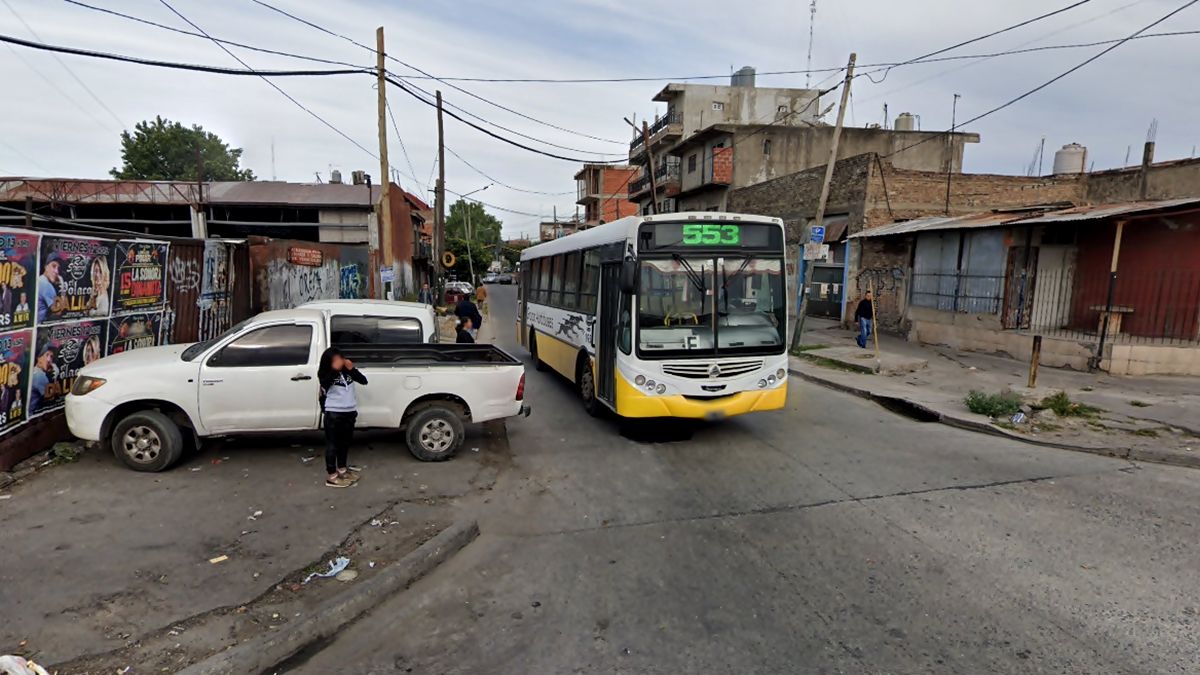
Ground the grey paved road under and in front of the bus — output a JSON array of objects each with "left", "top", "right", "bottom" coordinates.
[{"left": 296, "top": 287, "right": 1200, "bottom": 674}]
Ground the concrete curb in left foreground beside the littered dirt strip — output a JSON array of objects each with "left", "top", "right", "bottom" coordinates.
[{"left": 179, "top": 520, "right": 479, "bottom": 675}]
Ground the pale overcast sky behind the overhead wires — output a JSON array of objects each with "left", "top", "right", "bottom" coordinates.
[{"left": 0, "top": 0, "right": 1200, "bottom": 237}]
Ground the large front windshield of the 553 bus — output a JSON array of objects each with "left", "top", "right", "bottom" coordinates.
[{"left": 637, "top": 255, "right": 786, "bottom": 356}]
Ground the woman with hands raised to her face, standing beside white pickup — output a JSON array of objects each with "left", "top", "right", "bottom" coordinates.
[{"left": 317, "top": 347, "right": 367, "bottom": 488}]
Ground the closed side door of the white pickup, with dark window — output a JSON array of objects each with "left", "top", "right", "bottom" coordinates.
[{"left": 199, "top": 322, "right": 320, "bottom": 432}]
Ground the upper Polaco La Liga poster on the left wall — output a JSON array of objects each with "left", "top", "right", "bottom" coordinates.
[{"left": 36, "top": 234, "right": 113, "bottom": 325}]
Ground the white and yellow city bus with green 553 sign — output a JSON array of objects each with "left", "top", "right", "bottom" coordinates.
[{"left": 517, "top": 211, "right": 788, "bottom": 419}]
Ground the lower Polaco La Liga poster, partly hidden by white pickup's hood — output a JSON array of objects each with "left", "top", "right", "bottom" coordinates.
[{"left": 29, "top": 319, "right": 108, "bottom": 414}]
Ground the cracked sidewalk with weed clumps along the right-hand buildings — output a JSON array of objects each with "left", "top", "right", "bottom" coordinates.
[{"left": 791, "top": 317, "right": 1200, "bottom": 467}]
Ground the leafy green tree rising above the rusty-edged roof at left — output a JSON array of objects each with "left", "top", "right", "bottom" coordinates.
[{"left": 108, "top": 117, "right": 254, "bottom": 180}]
